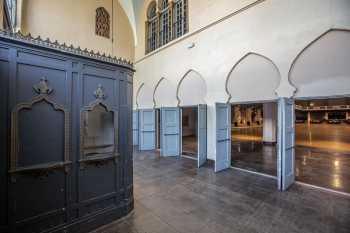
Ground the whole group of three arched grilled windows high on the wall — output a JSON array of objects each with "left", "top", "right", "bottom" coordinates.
[{"left": 146, "top": 0, "right": 188, "bottom": 53}]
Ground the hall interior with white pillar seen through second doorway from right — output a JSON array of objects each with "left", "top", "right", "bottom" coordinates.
[{"left": 231, "top": 102, "right": 277, "bottom": 176}]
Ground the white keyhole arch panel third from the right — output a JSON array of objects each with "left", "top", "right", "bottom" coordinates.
[{"left": 176, "top": 69, "right": 207, "bottom": 106}]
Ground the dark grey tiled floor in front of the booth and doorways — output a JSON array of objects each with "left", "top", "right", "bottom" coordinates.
[{"left": 91, "top": 149, "right": 350, "bottom": 233}]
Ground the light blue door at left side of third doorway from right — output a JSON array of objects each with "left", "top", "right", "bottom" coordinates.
[{"left": 161, "top": 108, "right": 180, "bottom": 157}]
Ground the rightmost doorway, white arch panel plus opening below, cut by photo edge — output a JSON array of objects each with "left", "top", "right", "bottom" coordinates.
[{"left": 289, "top": 29, "right": 350, "bottom": 193}]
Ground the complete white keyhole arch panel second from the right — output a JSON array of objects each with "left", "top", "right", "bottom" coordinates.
[{"left": 225, "top": 52, "right": 281, "bottom": 103}]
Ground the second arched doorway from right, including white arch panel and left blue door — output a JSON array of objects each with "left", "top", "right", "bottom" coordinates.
[{"left": 217, "top": 53, "right": 281, "bottom": 182}]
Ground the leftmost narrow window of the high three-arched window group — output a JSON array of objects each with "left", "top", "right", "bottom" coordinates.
[{"left": 146, "top": 1, "right": 158, "bottom": 52}]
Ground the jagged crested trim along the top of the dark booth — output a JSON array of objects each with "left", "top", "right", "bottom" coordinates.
[{"left": 0, "top": 30, "right": 134, "bottom": 70}]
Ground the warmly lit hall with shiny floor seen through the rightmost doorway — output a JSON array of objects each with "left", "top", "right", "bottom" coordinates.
[{"left": 295, "top": 98, "right": 350, "bottom": 193}]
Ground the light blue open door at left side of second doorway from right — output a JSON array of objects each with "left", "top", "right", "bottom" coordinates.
[{"left": 215, "top": 103, "right": 231, "bottom": 172}]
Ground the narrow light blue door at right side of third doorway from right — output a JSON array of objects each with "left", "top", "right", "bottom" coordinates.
[{"left": 197, "top": 104, "right": 207, "bottom": 167}]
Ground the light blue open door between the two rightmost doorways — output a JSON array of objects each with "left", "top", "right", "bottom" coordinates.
[{"left": 278, "top": 98, "right": 295, "bottom": 191}]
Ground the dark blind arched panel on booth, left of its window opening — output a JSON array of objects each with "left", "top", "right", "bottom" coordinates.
[{"left": 18, "top": 102, "right": 65, "bottom": 167}]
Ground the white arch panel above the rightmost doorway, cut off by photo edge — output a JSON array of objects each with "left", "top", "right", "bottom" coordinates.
[{"left": 288, "top": 28, "right": 350, "bottom": 97}]
